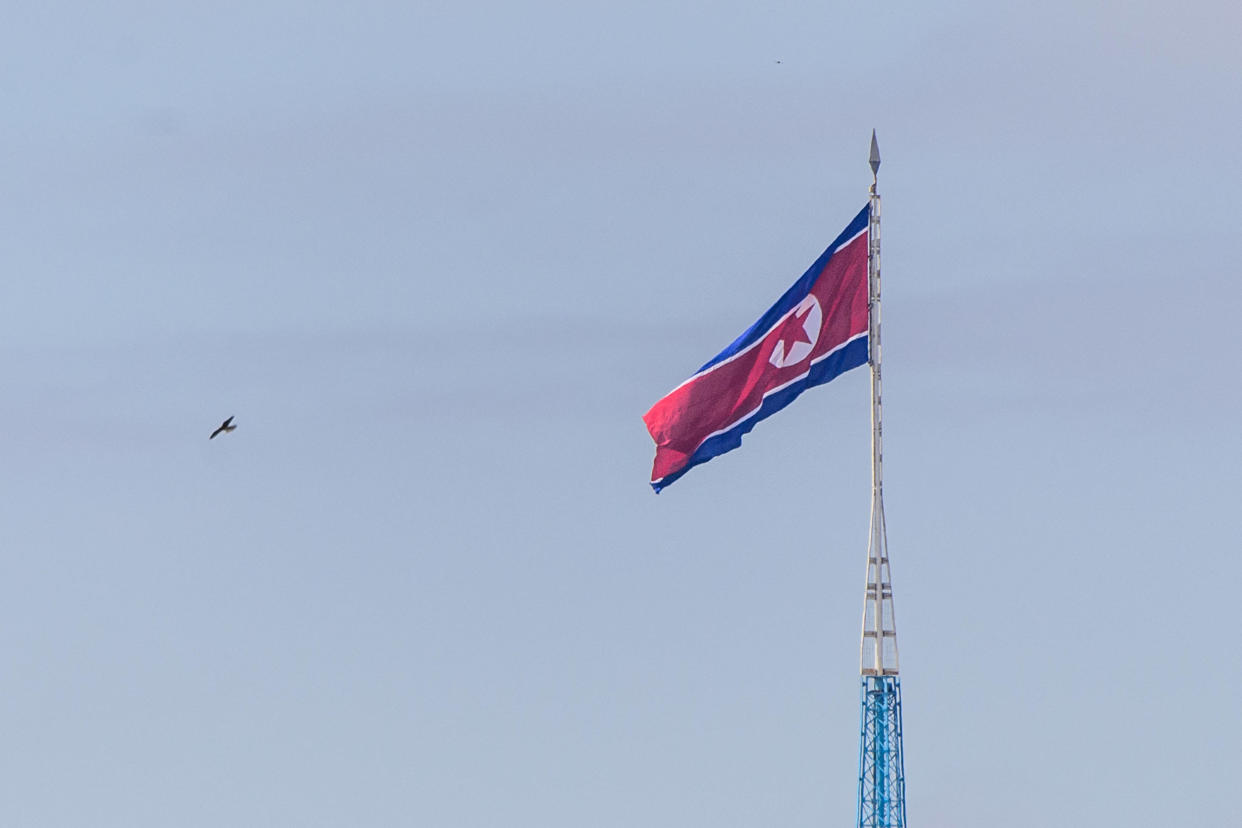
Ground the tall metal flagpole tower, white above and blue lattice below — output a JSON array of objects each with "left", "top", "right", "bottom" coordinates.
[{"left": 858, "top": 132, "right": 905, "bottom": 828}]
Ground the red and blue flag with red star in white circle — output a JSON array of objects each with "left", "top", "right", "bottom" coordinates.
[{"left": 642, "top": 207, "right": 869, "bottom": 492}]
